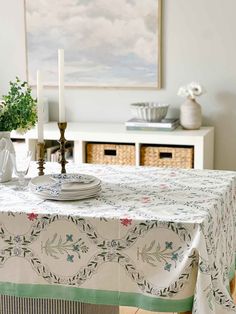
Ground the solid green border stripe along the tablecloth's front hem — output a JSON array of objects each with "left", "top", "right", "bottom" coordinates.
[{"left": 0, "top": 282, "right": 193, "bottom": 312}]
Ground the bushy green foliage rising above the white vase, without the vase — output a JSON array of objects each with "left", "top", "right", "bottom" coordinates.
[{"left": 0, "top": 77, "right": 37, "bottom": 132}]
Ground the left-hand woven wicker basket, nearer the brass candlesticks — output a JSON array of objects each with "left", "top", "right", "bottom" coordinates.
[{"left": 86, "top": 143, "right": 135, "bottom": 166}]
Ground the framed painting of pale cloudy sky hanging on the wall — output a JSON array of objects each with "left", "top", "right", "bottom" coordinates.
[{"left": 25, "top": 0, "right": 161, "bottom": 89}]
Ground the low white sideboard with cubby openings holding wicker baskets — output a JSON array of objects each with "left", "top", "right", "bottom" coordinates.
[{"left": 11, "top": 122, "right": 214, "bottom": 169}]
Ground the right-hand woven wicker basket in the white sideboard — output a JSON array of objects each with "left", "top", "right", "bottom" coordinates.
[{"left": 141, "top": 145, "right": 193, "bottom": 168}]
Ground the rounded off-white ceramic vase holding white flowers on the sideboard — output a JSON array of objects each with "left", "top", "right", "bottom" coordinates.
[{"left": 180, "top": 98, "right": 202, "bottom": 130}]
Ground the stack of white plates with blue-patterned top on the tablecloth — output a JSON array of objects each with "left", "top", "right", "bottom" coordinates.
[{"left": 29, "top": 173, "right": 101, "bottom": 201}]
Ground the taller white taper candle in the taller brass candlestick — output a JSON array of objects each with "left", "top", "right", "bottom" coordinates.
[{"left": 58, "top": 49, "right": 66, "bottom": 122}]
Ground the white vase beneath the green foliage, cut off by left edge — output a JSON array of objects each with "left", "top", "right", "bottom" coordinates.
[{"left": 0, "top": 132, "right": 15, "bottom": 182}]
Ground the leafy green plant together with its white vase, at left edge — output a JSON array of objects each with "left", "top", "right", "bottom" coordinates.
[{"left": 0, "top": 77, "right": 37, "bottom": 182}]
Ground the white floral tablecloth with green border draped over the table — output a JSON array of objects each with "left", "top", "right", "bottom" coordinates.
[{"left": 0, "top": 164, "right": 236, "bottom": 314}]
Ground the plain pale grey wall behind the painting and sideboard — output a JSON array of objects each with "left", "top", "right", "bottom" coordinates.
[{"left": 0, "top": 0, "right": 236, "bottom": 170}]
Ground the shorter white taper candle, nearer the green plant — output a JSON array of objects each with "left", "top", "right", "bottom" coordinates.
[{"left": 37, "top": 71, "right": 43, "bottom": 143}]
